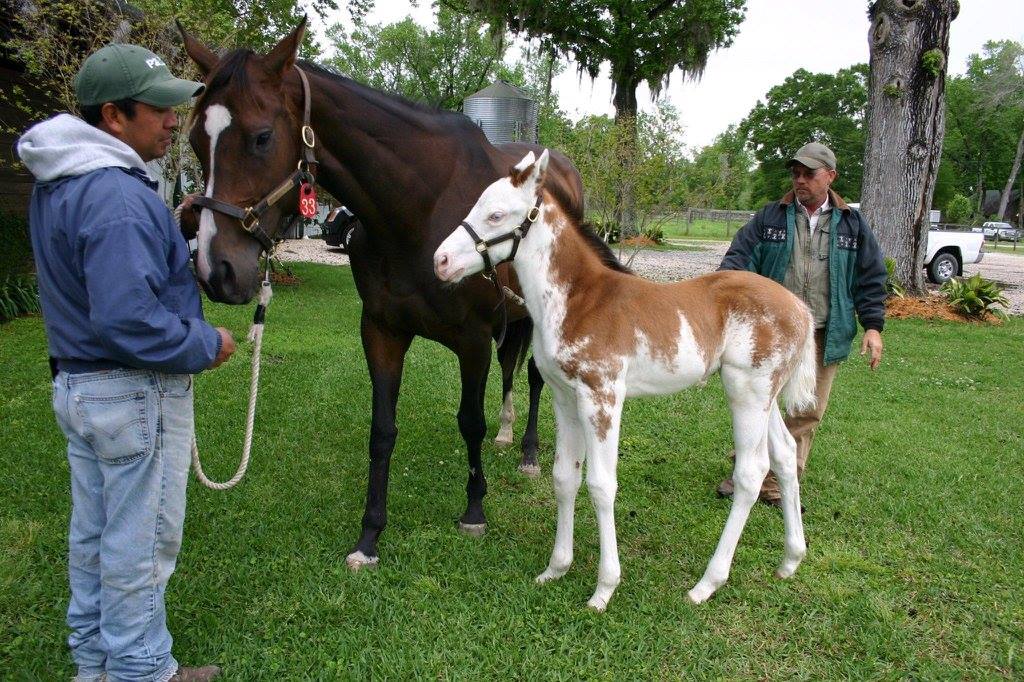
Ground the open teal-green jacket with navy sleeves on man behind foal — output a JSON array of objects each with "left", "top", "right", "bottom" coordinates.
[{"left": 718, "top": 189, "right": 886, "bottom": 365}]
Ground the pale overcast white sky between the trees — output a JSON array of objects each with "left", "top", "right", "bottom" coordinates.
[{"left": 312, "top": 0, "right": 1024, "bottom": 148}]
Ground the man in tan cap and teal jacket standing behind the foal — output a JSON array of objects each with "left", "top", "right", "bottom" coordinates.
[{"left": 718, "top": 142, "right": 886, "bottom": 505}]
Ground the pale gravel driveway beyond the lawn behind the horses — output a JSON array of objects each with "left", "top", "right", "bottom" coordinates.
[{"left": 278, "top": 240, "right": 1024, "bottom": 315}]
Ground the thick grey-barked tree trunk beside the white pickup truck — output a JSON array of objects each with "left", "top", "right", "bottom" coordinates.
[{"left": 860, "top": 0, "right": 959, "bottom": 294}]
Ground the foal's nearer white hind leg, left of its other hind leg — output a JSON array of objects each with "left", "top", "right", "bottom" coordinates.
[{"left": 687, "top": 366, "right": 772, "bottom": 604}]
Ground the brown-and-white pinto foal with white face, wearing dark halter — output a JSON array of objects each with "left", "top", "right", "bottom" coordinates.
[{"left": 434, "top": 152, "right": 815, "bottom": 610}]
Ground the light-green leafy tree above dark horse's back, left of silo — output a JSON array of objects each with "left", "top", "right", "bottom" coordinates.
[{"left": 328, "top": 7, "right": 525, "bottom": 111}]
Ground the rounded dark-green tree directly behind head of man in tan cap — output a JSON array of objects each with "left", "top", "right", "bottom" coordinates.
[{"left": 739, "top": 63, "right": 867, "bottom": 204}]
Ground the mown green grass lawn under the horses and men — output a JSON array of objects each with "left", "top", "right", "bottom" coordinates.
[{"left": 0, "top": 265, "right": 1024, "bottom": 680}]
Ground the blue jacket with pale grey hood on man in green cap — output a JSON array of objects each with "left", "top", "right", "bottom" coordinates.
[{"left": 17, "top": 114, "right": 221, "bottom": 374}]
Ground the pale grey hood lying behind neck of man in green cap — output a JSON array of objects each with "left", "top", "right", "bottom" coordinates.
[{"left": 17, "top": 114, "right": 148, "bottom": 182}]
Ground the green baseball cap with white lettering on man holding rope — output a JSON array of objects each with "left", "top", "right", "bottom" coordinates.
[{"left": 75, "top": 43, "right": 203, "bottom": 108}]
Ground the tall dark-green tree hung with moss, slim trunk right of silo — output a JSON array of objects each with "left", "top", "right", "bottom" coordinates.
[{"left": 441, "top": 0, "right": 745, "bottom": 231}]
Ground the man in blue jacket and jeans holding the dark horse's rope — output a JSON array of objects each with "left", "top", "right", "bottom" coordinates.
[{"left": 17, "top": 45, "right": 234, "bottom": 682}]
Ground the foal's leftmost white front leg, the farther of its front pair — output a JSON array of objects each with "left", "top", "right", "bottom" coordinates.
[{"left": 537, "top": 387, "right": 586, "bottom": 583}]
